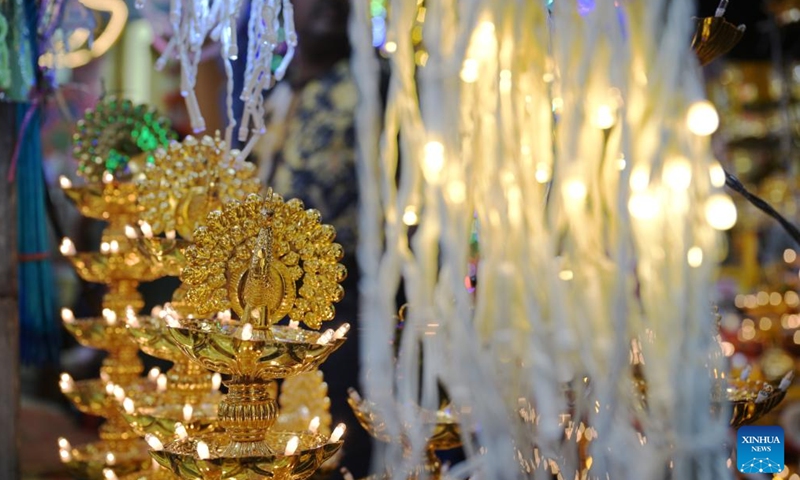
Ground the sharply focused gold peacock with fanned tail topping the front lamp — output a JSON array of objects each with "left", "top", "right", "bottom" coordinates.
[{"left": 181, "top": 191, "right": 347, "bottom": 329}]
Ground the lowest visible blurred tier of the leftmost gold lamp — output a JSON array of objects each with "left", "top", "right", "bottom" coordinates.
[{"left": 64, "top": 439, "right": 151, "bottom": 480}]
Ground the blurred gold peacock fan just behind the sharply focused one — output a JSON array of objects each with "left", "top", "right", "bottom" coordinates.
[{"left": 135, "top": 134, "right": 260, "bottom": 240}]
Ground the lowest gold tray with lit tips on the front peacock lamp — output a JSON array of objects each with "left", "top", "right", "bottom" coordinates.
[{"left": 150, "top": 432, "right": 342, "bottom": 480}]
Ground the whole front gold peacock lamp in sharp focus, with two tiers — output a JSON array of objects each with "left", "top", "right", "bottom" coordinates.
[{"left": 148, "top": 192, "right": 347, "bottom": 480}]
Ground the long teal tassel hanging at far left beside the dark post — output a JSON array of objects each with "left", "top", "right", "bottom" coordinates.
[{"left": 16, "top": 104, "right": 60, "bottom": 365}]
